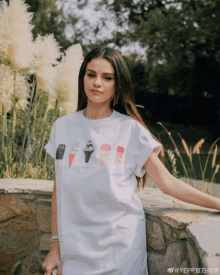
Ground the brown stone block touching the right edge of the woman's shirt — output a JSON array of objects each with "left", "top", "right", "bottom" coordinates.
[{"left": 147, "top": 220, "right": 165, "bottom": 250}]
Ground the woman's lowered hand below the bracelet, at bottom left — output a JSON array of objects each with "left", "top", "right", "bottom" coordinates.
[{"left": 42, "top": 250, "right": 62, "bottom": 275}]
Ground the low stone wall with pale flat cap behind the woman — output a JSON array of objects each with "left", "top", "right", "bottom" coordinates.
[{"left": 0, "top": 179, "right": 220, "bottom": 275}]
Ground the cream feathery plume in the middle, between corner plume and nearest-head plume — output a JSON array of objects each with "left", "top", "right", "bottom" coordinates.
[{"left": 31, "top": 34, "right": 61, "bottom": 91}]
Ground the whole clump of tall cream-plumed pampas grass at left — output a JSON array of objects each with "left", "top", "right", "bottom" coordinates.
[{"left": 0, "top": 0, "right": 83, "bottom": 179}]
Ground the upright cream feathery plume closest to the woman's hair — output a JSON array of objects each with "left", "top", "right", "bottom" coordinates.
[{"left": 54, "top": 44, "right": 84, "bottom": 113}]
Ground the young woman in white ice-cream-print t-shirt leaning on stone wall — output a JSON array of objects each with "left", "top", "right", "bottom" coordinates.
[{"left": 42, "top": 47, "right": 220, "bottom": 275}]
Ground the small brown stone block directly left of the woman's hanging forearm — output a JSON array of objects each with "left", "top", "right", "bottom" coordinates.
[{"left": 37, "top": 204, "right": 51, "bottom": 232}]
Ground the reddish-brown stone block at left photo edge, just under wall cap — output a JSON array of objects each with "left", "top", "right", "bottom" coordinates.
[{"left": 0, "top": 195, "right": 33, "bottom": 222}]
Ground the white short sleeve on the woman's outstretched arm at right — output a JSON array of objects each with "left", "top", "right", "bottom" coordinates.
[{"left": 134, "top": 124, "right": 163, "bottom": 177}]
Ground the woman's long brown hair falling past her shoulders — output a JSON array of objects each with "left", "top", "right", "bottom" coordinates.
[{"left": 77, "top": 47, "right": 164, "bottom": 191}]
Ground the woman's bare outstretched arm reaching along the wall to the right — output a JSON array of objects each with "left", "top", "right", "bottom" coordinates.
[{"left": 143, "top": 151, "right": 220, "bottom": 210}]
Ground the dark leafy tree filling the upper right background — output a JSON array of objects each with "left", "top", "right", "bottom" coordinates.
[{"left": 90, "top": 0, "right": 220, "bottom": 128}]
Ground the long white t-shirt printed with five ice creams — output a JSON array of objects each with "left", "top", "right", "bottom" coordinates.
[{"left": 44, "top": 110, "right": 162, "bottom": 275}]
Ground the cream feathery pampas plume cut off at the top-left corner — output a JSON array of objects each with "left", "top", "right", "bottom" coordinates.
[{"left": 0, "top": 0, "right": 34, "bottom": 69}]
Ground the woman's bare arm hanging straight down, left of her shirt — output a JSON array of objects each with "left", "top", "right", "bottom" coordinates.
[{"left": 50, "top": 160, "right": 59, "bottom": 251}]
